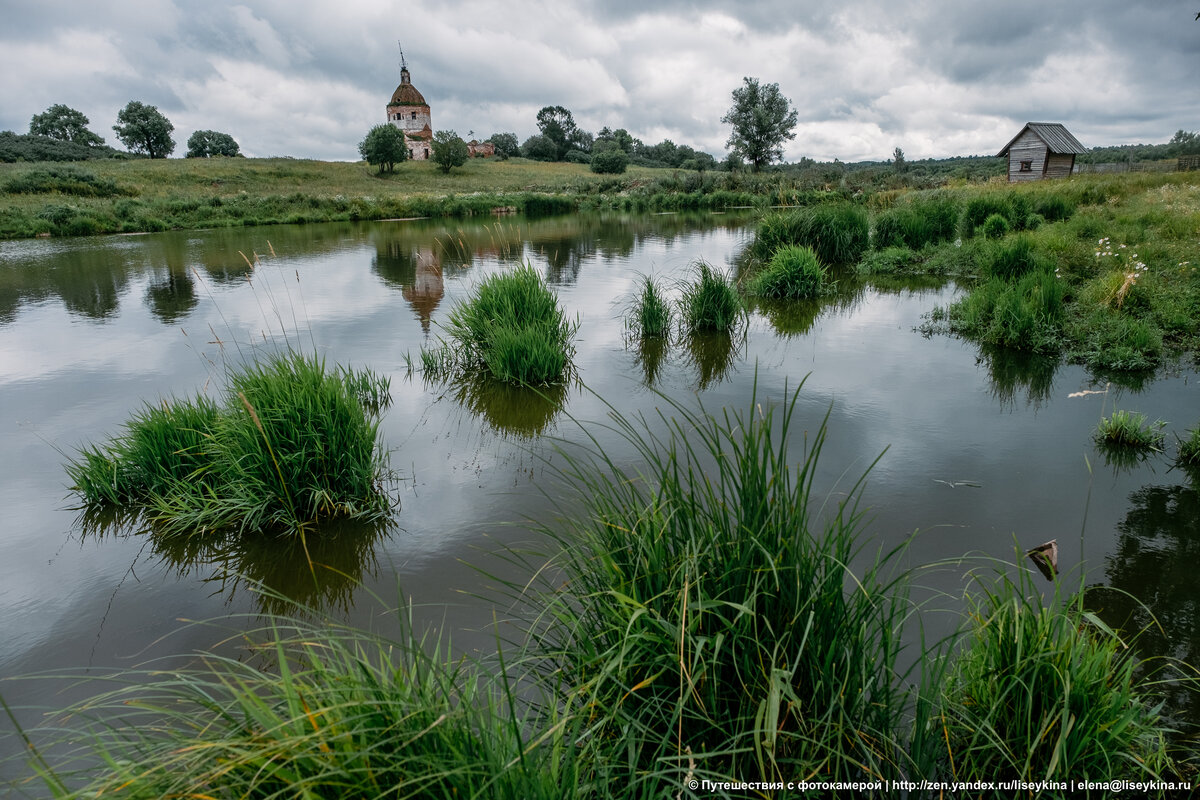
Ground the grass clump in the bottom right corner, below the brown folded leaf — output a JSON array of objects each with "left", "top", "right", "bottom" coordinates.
[{"left": 934, "top": 575, "right": 1172, "bottom": 796}]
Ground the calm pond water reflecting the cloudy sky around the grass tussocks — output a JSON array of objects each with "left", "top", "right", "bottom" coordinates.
[{"left": 0, "top": 215, "right": 1200, "bottom": 776}]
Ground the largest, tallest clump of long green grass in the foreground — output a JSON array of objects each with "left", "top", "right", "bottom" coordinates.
[{"left": 542, "top": 386, "right": 908, "bottom": 796}]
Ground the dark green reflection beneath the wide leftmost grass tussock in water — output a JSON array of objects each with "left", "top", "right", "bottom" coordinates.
[{"left": 78, "top": 507, "right": 394, "bottom": 614}]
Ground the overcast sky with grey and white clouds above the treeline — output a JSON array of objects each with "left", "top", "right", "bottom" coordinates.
[{"left": 0, "top": 0, "right": 1200, "bottom": 161}]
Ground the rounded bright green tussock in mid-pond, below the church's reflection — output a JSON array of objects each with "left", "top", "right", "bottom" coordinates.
[{"left": 421, "top": 265, "right": 578, "bottom": 386}]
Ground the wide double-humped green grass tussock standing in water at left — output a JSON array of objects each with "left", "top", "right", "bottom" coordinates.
[{"left": 66, "top": 353, "right": 390, "bottom": 533}]
